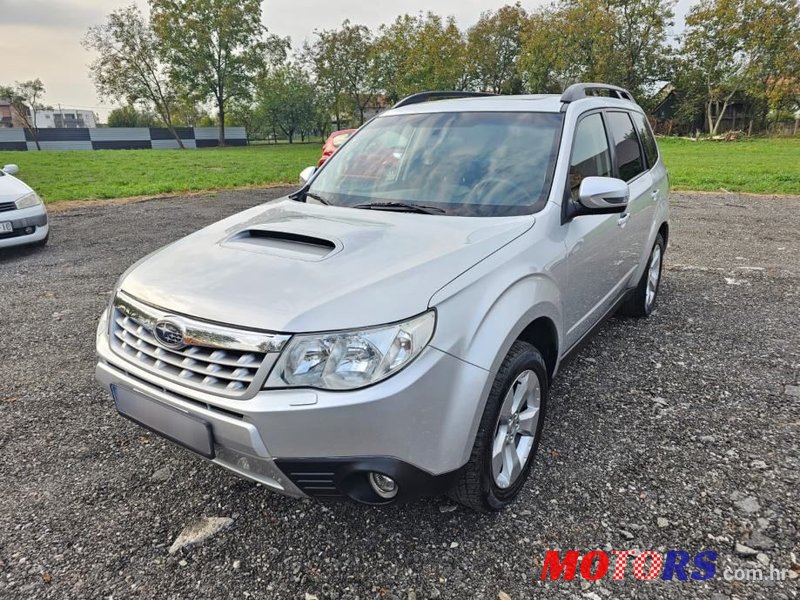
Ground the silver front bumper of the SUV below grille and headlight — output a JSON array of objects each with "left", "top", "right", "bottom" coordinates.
[{"left": 96, "top": 310, "right": 489, "bottom": 503}]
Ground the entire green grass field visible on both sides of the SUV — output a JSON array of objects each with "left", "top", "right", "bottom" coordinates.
[{"left": 0, "top": 138, "right": 800, "bottom": 203}]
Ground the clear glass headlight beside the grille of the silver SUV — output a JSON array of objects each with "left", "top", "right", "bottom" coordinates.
[{"left": 265, "top": 311, "right": 436, "bottom": 390}]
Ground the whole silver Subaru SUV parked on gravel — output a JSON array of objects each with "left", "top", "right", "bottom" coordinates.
[{"left": 97, "top": 84, "right": 669, "bottom": 511}]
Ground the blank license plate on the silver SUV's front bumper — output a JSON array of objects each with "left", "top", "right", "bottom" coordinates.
[{"left": 111, "top": 385, "right": 214, "bottom": 459}]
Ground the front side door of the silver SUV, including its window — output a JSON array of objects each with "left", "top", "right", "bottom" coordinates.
[{"left": 564, "top": 112, "right": 628, "bottom": 346}]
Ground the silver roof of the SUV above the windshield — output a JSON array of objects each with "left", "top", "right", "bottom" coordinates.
[{"left": 379, "top": 94, "right": 641, "bottom": 117}]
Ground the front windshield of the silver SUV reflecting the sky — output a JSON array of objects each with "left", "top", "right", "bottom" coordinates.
[{"left": 308, "top": 112, "right": 562, "bottom": 217}]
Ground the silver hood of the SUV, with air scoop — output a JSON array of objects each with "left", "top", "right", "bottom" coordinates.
[{"left": 120, "top": 199, "right": 534, "bottom": 333}]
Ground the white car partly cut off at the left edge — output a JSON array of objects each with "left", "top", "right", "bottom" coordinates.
[{"left": 0, "top": 165, "right": 50, "bottom": 249}]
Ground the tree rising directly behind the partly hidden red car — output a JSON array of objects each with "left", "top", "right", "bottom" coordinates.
[{"left": 304, "top": 21, "right": 378, "bottom": 128}]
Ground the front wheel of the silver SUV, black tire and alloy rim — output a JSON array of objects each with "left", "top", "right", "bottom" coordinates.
[{"left": 449, "top": 341, "right": 549, "bottom": 512}]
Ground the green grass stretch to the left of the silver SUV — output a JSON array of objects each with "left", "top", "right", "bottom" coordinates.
[{"left": 0, "top": 144, "right": 321, "bottom": 203}]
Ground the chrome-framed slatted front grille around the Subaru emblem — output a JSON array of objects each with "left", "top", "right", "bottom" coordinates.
[{"left": 109, "top": 293, "right": 290, "bottom": 399}]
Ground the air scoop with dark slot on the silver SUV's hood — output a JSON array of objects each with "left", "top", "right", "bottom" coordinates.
[{"left": 221, "top": 228, "right": 341, "bottom": 261}]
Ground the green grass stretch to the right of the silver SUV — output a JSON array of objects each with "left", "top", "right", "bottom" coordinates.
[{"left": 658, "top": 137, "right": 800, "bottom": 196}]
